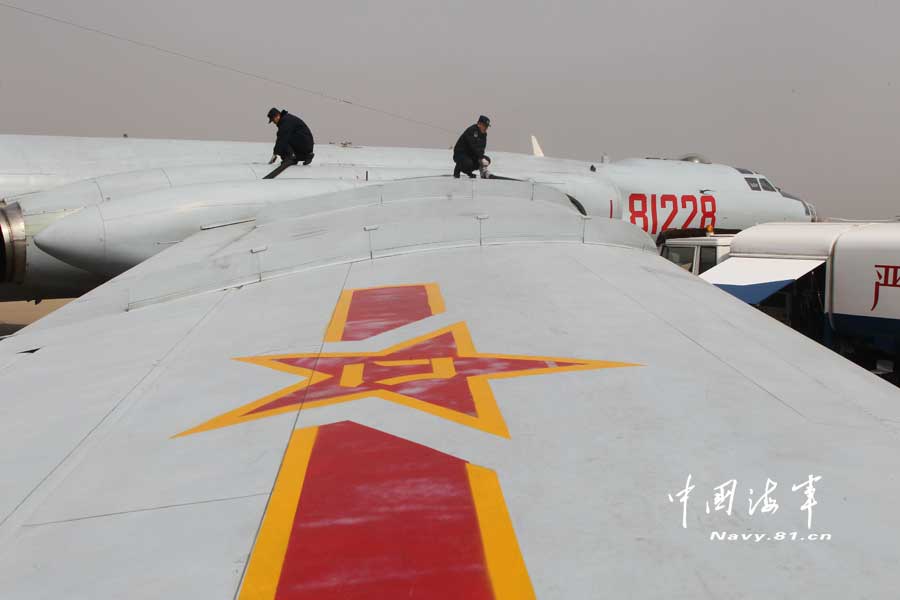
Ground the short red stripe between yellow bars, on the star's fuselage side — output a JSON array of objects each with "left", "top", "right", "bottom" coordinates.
[{"left": 341, "top": 285, "right": 431, "bottom": 342}]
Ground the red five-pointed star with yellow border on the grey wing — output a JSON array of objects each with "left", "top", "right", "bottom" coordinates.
[{"left": 178, "top": 323, "right": 636, "bottom": 437}]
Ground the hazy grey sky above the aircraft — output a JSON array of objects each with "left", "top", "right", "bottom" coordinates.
[{"left": 0, "top": 0, "right": 900, "bottom": 218}]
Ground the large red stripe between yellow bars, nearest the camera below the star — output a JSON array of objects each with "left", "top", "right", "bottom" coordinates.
[{"left": 275, "top": 422, "right": 493, "bottom": 600}]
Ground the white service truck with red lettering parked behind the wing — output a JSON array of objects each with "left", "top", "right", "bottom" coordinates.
[{"left": 661, "top": 222, "right": 900, "bottom": 383}]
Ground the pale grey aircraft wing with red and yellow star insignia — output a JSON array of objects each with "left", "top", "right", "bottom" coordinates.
[{"left": 0, "top": 179, "right": 900, "bottom": 599}]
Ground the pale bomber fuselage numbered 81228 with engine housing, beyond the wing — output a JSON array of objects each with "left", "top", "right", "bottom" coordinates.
[{"left": 0, "top": 136, "right": 815, "bottom": 300}]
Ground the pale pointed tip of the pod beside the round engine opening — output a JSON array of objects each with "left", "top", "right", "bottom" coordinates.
[{"left": 34, "top": 206, "right": 106, "bottom": 273}]
